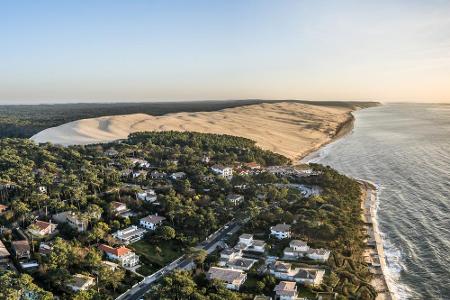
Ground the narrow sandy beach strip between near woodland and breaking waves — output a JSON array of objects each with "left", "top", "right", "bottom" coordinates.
[{"left": 360, "top": 181, "right": 397, "bottom": 300}]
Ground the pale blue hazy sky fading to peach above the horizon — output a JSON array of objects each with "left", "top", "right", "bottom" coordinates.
[{"left": 0, "top": 0, "right": 450, "bottom": 103}]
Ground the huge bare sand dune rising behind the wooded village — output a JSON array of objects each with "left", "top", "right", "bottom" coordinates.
[{"left": 31, "top": 102, "right": 350, "bottom": 158}]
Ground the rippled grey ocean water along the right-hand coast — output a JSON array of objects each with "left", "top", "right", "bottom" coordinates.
[{"left": 305, "top": 104, "right": 450, "bottom": 299}]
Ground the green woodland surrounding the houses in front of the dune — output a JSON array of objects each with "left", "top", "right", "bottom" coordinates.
[{"left": 0, "top": 132, "right": 375, "bottom": 299}]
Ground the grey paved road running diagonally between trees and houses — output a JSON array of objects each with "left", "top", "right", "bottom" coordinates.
[{"left": 116, "top": 220, "right": 242, "bottom": 300}]
